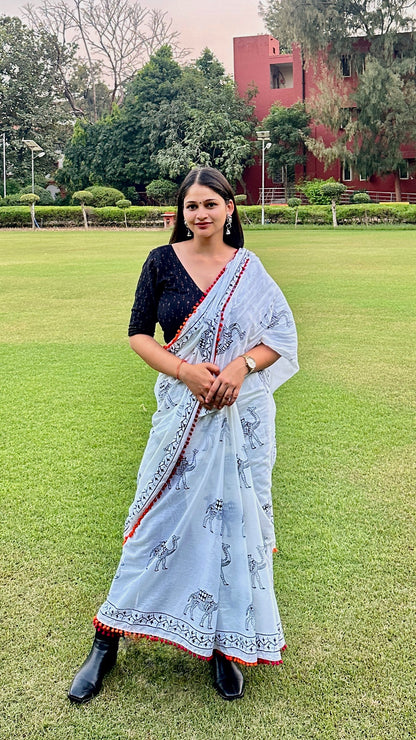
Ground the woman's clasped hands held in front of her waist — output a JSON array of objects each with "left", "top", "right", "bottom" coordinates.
[{"left": 179, "top": 357, "right": 247, "bottom": 409}]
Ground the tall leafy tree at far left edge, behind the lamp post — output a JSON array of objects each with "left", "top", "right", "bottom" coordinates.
[{"left": 0, "top": 16, "right": 71, "bottom": 184}]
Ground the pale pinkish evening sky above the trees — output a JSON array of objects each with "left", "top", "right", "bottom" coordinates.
[{"left": 0, "top": 0, "right": 266, "bottom": 73}]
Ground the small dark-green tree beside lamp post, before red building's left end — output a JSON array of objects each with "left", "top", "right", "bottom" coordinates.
[{"left": 262, "top": 103, "right": 310, "bottom": 200}]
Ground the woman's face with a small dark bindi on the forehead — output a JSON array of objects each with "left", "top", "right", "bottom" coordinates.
[{"left": 183, "top": 183, "right": 234, "bottom": 237}]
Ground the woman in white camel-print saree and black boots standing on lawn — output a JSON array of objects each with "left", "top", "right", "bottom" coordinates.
[{"left": 68, "top": 168, "right": 298, "bottom": 703}]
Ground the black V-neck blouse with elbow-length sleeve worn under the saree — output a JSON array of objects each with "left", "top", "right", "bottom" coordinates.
[{"left": 129, "top": 244, "right": 204, "bottom": 343}]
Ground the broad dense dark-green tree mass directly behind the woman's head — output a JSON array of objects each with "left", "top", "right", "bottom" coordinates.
[{"left": 60, "top": 46, "right": 255, "bottom": 190}]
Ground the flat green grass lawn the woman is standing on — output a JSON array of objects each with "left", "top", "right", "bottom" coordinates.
[{"left": 0, "top": 228, "right": 416, "bottom": 740}]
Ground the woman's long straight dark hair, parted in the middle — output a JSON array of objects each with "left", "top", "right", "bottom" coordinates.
[{"left": 169, "top": 167, "right": 244, "bottom": 249}]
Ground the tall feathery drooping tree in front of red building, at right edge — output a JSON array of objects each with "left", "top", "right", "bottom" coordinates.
[{"left": 262, "top": 0, "right": 416, "bottom": 199}]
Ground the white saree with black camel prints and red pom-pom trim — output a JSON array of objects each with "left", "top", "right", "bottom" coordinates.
[{"left": 94, "top": 249, "right": 298, "bottom": 665}]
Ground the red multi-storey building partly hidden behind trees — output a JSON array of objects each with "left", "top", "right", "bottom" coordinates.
[{"left": 234, "top": 34, "right": 416, "bottom": 203}]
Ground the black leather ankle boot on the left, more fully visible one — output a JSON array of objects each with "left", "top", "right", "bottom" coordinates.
[{"left": 68, "top": 632, "right": 119, "bottom": 704}]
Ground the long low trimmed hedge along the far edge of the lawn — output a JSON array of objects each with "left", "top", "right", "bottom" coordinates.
[{"left": 0, "top": 203, "right": 416, "bottom": 228}]
